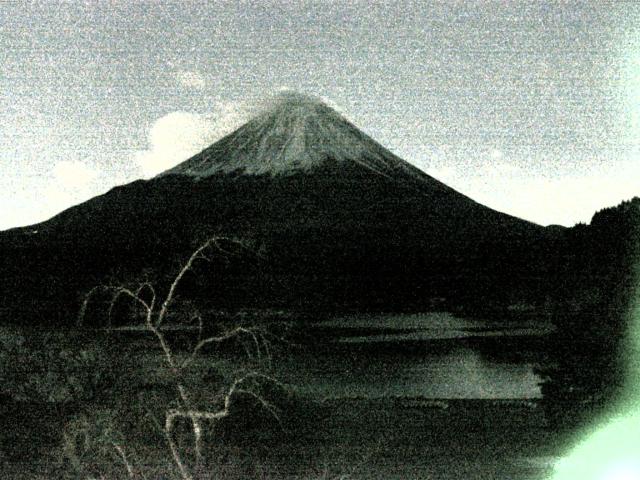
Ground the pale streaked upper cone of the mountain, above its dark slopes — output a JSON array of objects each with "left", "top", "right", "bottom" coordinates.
[{"left": 163, "top": 92, "right": 424, "bottom": 178}]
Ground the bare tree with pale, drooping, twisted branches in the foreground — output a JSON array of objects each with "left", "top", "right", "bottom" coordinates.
[{"left": 78, "top": 237, "right": 280, "bottom": 480}]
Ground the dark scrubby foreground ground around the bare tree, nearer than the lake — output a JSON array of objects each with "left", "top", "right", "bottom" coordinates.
[{"left": 0, "top": 331, "right": 558, "bottom": 480}]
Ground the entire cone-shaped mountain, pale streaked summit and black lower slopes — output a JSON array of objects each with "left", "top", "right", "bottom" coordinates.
[{"left": 0, "top": 94, "right": 563, "bottom": 322}]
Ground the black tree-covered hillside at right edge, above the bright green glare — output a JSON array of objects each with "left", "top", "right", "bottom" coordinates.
[{"left": 541, "top": 197, "right": 640, "bottom": 429}]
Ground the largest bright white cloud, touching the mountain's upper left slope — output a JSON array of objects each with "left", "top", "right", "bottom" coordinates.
[{"left": 134, "top": 103, "right": 246, "bottom": 178}]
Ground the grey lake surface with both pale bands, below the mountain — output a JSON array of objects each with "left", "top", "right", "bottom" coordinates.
[{"left": 282, "top": 313, "right": 548, "bottom": 399}]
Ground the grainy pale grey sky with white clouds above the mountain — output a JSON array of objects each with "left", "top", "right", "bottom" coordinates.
[{"left": 0, "top": 0, "right": 640, "bottom": 229}]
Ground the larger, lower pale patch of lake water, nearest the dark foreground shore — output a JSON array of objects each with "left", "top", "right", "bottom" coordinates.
[{"left": 284, "top": 349, "right": 540, "bottom": 399}]
